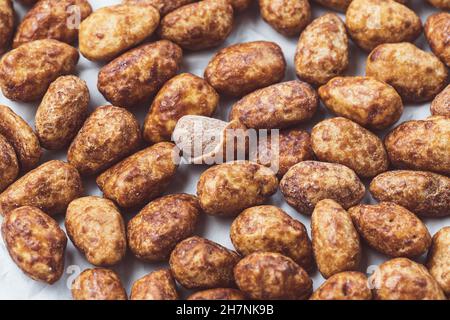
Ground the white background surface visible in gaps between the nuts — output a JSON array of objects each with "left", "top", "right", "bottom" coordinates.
[{"left": 0, "top": 0, "right": 450, "bottom": 299}]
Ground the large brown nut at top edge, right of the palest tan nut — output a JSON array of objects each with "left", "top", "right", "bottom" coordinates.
[{"left": 159, "top": 0, "right": 234, "bottom": 51}]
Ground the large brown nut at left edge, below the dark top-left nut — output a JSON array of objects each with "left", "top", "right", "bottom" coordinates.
[{"left": 0, "top": 39, "right": 79, "bottom": 102}]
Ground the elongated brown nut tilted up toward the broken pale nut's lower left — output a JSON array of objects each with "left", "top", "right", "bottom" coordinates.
[{"left": 97, "top": 142, "right": 178, "bottom": 208}]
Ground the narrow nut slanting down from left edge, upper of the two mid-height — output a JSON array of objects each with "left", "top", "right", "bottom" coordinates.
[{"left": 0, "top": 105, "right": 42, "bottom": 172}]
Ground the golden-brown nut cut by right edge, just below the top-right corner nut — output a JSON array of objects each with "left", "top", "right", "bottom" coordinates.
[{"left": 425, "top": 12, "right": 450, "bottom": 67}]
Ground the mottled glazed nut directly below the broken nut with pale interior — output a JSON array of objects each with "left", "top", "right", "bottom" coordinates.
[{"left": 197, "top": 161, "right": 278, "bottom": 216}]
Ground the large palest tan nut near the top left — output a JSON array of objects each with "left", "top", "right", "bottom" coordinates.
[{"left": 79, "top": 3, "right": 160, "bottom": 61}]
